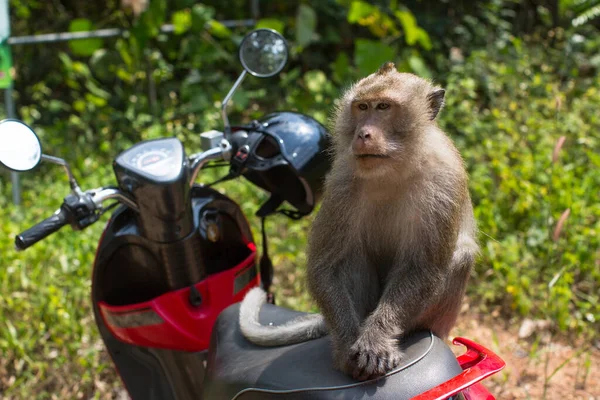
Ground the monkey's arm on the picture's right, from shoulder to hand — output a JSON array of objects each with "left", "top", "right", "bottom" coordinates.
[{"left": 349, "top": 185, "right": 468, "bottom": 379}]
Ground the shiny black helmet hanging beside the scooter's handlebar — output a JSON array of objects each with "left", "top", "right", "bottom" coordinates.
[{"left": 232, "top": 112, "right": 331, "bottom": 218}]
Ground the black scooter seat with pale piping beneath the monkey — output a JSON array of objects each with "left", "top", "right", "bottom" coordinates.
[{"left": 204, "top": 303, "right": 462, "bottom": 400}]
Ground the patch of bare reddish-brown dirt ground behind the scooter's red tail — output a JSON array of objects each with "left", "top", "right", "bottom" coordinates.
[{"left": 450, "top": 304, "right": 600, "bottom": 400}]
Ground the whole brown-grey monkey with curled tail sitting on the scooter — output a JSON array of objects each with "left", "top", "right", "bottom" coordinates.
[{"left": 240, "top": 62, "right": 479, "bottom": 380}]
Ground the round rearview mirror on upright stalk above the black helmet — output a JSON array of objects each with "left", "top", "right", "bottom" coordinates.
[{"left": 240, "top": 29, "right": 288, "bottom": 78}]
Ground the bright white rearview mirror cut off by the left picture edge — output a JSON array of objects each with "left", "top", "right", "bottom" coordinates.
[{"left": 0, "top": 119, "right": 42, "bottom": 172}]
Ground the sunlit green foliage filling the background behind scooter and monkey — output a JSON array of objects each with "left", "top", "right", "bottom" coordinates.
[{"left": 0, "top": 0, "right": 600, "bottom": 398}]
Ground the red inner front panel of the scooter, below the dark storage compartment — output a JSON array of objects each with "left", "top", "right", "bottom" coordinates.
[{"left": 99, "top": 243, "right": 260, "bottom": 351}]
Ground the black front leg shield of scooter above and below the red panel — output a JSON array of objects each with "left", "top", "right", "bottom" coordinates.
[{"left": 92, "top": 186, "right": 253, "bottom": 400}]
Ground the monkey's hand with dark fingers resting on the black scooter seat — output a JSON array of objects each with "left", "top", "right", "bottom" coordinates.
[{"left": 346, "top": 337, "right": 403, "bottom": 381}]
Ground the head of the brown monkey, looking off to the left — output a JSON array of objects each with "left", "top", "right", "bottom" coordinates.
[{"left": 335, "top": 68, "right": 444, "bottom": 177}]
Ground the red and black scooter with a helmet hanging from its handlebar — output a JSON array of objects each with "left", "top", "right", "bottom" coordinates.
[{"left": 0, "top": 29, "right": 505, "bottom": 400}]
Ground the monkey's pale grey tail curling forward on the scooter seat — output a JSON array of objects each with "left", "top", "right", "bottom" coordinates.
[{"left": 240, "top": 287, "right": 327, "bottom": 347}]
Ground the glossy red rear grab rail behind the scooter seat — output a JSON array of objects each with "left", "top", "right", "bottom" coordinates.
[{"left": 412, "top": 337, "right": 506, "bottom": 400}]
